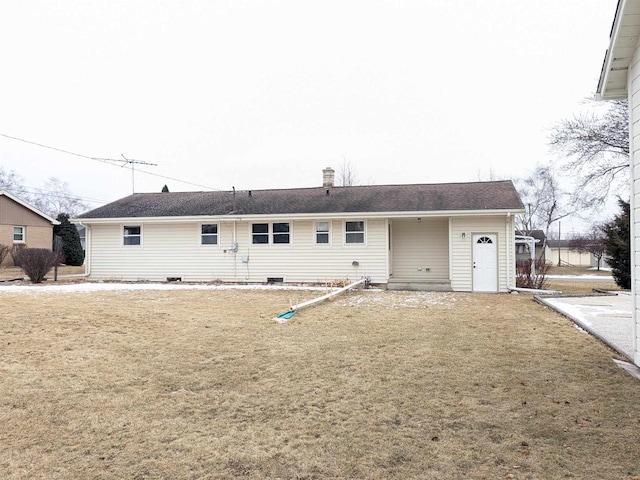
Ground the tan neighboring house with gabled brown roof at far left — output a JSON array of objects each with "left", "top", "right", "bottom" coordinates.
[{"left": 0, "top": 190, "right": 60, "bottom": 265}]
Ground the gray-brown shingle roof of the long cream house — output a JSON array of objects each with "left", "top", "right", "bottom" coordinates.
[{"left": 78, "top": 181, "right": 524, "bottom": 219}]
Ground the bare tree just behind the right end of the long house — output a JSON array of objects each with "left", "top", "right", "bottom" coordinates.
[{"left": 516, "top": 165, "right": 575, "bottom": 252}]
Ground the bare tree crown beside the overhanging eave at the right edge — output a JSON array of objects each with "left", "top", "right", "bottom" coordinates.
[{"left": 549, "top": 100, "right": 629, "bottom": 208}]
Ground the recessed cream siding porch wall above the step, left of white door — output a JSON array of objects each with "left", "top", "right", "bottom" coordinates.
[{"left": 391, "top": 218, "right": 449, "bottom": 282}]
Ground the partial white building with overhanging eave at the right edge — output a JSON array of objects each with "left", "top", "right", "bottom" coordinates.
[{"left": 597, "top": 0, "right": 640, "bottom": 366}]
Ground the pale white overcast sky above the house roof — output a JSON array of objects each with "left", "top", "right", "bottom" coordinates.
[{"left": 0, "top": 0, "right": 617, "bottom": 229}]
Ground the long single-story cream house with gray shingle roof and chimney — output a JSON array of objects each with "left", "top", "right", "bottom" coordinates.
[{"left": 73, "top": 168, "right": 524, "bottom": 292}]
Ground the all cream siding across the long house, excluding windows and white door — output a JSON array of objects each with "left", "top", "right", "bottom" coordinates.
[{"left": 88, "top": 215, "right": 515, "bottom": 291}]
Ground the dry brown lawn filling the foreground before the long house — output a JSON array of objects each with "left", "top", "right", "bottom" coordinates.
[{"left": 0, "top": 287, "right": 640, "bottom": 479}]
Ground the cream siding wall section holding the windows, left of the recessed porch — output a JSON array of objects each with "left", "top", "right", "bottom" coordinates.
[{"left": 89, "top": 219, "right": 388, "bottom": 283}]
